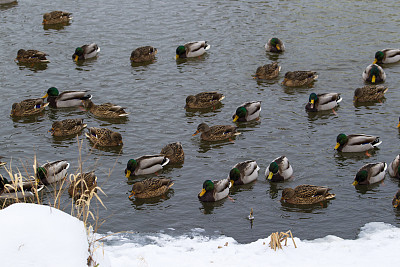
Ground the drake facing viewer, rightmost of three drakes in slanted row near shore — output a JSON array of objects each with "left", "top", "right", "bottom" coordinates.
[{"left": 265, "top": 156, "right": 293, "bottom": 182}]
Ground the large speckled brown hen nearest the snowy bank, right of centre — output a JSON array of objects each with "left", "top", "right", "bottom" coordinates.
[{"left": 281, "top": 184, "right": 336, "bottom": 205}]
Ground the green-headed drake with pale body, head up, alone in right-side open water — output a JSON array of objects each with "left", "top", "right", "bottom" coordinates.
[{"left": 335, "top": 133, "right": 382, "bottom": 152}]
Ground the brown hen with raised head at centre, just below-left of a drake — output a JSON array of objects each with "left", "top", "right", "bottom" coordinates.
[{"left": 193, "top": 122, "right": 240, "bottom": 141}]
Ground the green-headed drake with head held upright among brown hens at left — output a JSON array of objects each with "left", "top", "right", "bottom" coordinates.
[{"left": 42, "top": 87, "right": 92, "bottom": 108}]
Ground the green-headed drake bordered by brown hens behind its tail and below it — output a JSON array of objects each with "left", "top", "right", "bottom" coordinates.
[{"left": 125, "top": 155, "right": 169, "bottom": 178}]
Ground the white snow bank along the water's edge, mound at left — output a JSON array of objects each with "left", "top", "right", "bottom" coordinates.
[{"left": 0, "top": 204, "right": 400, "bottom": 267}]
